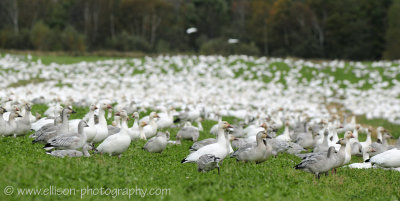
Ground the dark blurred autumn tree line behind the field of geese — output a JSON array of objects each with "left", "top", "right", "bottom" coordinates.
[{"left": 0, "top": 0, "right": 400, "bottom": 60}]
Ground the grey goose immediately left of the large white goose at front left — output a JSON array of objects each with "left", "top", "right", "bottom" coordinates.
[{"left": 44, "top": 120, "right": 88, "bottom": 150}]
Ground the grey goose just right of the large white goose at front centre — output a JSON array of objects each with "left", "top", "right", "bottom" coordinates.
[{"left": 232, "top": 131, "right": 272, "bottom": 164}]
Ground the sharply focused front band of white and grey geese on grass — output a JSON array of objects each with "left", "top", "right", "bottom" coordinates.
[{"left": 0, "top": 98, "right": 400, "bottom": 178}]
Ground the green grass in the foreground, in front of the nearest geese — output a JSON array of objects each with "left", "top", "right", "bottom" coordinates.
[{"left": 0, "top": 105, "right": 400, "bottom": 200}]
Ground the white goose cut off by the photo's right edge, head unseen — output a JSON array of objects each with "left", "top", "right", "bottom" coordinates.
[{"left": 370, "top": 148, "right": 400, "bottom": 168}]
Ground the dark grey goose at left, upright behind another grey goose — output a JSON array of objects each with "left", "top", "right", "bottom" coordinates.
[{"left": 32, "top": 107, "right": 75, "bottom": 143}]
